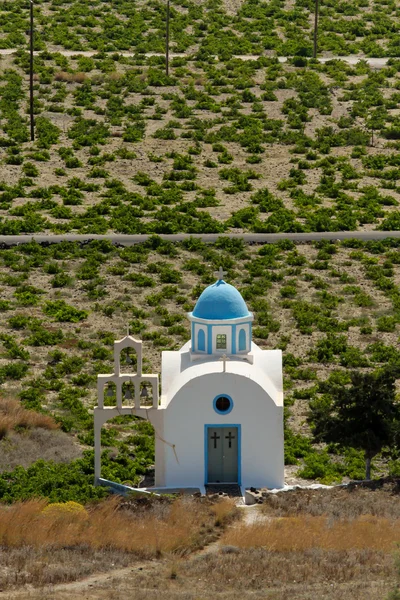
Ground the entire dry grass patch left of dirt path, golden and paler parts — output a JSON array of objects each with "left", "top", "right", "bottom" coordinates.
[{"left": 0, "top": 497, "right": 237, "bottom": 596}]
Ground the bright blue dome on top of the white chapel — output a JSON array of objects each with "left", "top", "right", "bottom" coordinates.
[{"left": 192, "top": 279, "right": 251, "bottom": 321}]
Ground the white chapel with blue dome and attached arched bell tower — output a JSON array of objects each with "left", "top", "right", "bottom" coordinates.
[{"left": 95, "top": 270, "right": 284, "bottom": 491}]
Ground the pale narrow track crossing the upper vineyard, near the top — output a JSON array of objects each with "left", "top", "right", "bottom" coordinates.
[{"left": 0, "top": 48, "right": 390, "bottom": 69}]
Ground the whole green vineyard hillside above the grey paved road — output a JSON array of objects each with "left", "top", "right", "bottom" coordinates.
[{"left": 0, "top": 1, "right": 400, "bottom": 235}]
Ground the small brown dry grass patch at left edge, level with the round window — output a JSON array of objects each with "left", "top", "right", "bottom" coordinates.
[{"left": 0, "top": 398, "right": 59, "bottom": 439}]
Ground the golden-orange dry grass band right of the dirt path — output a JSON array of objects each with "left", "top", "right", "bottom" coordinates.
[{"left": 222, "top": 515, "right": 400, "bottom": 552}]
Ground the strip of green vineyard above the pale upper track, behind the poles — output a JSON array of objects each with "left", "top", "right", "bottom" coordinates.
[{"left": 1, "top": 0, "right": 400, "bottom": 59}]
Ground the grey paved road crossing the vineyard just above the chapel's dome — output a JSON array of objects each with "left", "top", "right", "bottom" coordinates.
[{"left": 0, "top": 231, "right": 400, "bottom": 247}]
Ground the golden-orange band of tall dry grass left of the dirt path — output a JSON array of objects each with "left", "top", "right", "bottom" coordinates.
[{"left": 0, "top": 497, "right": 233, "bottom": 558}]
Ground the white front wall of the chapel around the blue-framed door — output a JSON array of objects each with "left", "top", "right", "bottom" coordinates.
[{"left": 156, "top": 366, "right": 284, "bottom": 488}]
